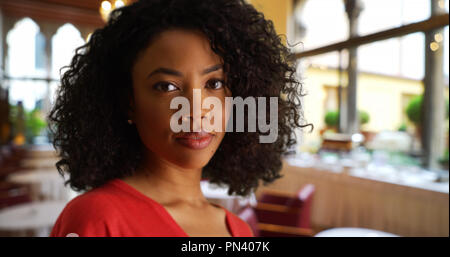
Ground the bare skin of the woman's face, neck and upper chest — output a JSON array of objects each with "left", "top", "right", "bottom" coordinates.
[{"left": 123, "top": 29, "right": 231, "bottom": 236}]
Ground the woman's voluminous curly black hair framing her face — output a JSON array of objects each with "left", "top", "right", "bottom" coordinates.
[{"left": 48, "top": 0, "right": 311, "bottom": 196}]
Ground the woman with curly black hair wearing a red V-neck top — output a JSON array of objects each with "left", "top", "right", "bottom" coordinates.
[{"left": 49, "top": 0, "right": 310, "bottom": 236}]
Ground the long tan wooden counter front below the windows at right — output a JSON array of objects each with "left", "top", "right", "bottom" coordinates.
[{"left": 257, "top": 160, "right": 449, "bottom": 237}]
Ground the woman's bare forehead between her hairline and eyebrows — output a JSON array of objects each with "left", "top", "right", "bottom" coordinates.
[{"left": 136, "top": 29, "right": 221, "bottom": 72}]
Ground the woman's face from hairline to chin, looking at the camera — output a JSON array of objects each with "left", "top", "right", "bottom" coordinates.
[{"left": 130, "top": 29, "right": 231, "bottom": 169}]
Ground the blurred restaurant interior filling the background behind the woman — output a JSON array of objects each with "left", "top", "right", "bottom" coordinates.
[{"left": 0, "top": 0, "right": 449, "bottom": 237}]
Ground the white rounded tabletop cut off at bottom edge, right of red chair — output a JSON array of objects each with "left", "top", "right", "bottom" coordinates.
[{"left": 314, "top": 228, "right": 398, "bottom": 237}]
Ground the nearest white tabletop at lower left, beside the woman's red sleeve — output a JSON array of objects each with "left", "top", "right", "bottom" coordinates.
[{"left": 0, "top": 201, "right": 67, "bottom": 236}]
